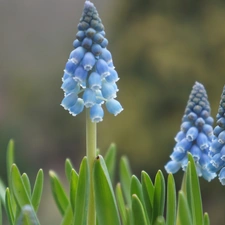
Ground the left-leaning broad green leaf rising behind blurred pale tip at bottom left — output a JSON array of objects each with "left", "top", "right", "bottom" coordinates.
[{"left": 11, "top": 164, "right": 31, "bottom": 208}]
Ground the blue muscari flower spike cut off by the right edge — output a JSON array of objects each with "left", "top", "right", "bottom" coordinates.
[{"left": 208, "top": 86, "right": 225, "bottom": 185}]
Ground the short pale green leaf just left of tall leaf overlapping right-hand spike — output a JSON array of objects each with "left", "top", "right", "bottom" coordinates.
[{"left": 176, "top": 191, "right": 193, "bottom": 225}]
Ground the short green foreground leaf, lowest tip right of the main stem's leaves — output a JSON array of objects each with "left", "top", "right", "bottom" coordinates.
[{"left": 132, "top": 194, "right": 148, "bottom": 225}]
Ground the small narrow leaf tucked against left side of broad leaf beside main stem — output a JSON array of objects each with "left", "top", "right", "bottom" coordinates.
[{"left": 70, "top": 169, "right": 79, "bottom": 212}]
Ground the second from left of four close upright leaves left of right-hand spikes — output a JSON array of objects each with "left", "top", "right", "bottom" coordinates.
[{"left": 141, "top": 171, "right": 155, "bottom": 221}]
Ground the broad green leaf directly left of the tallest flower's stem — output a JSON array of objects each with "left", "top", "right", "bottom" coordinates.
[{"left": 73, "top": 157, "right": 90, "bottom": 225}]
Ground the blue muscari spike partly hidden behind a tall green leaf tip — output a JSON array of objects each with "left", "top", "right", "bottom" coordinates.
[{"left": 165, "top": 82, "right": 216, "bottom": 181}]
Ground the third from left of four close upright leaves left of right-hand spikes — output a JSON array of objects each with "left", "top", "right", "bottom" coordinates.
[{"left": 152, "top": 170, "right": 165, "bottom": 223}]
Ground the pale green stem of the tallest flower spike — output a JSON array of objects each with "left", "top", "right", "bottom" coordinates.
[{"left": 86, "top": 109, "right": 97, "bottom": 225}]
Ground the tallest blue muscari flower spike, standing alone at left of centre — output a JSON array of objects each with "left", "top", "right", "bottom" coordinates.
[{"left": 61, "top": 1, "right": 123, "bottom": 122}]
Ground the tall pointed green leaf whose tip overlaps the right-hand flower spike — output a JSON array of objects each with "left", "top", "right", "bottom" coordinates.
[{"left": 188, "top": 154, "right": 203, "bottom": 225}]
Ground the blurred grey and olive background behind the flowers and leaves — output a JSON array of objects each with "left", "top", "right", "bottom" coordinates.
[{"left": 0, "top": 0, "right": 225, "bottom": 225}]
